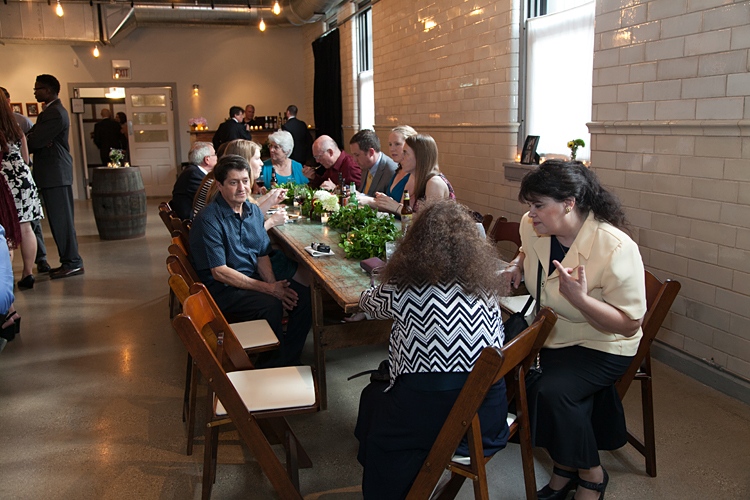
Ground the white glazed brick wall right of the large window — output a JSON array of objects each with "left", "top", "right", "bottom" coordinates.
[{"left": 590, "top": 0, "right": 750, "bottom": 378}]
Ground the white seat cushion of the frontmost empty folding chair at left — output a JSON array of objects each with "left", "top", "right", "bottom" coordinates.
[{"left": 216, "top": 366, "right": 315, "bottom": 415}]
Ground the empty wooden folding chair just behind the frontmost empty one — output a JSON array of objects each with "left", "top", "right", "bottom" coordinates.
[{"left": 167, "top": 264, "right": 279, "bottom": 455}]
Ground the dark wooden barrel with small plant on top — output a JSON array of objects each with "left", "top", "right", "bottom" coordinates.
[{"left": 91, "top": 167, "right": 146, "bottom": 240}]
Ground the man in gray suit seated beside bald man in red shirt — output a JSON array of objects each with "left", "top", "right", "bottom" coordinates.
[{"left": 349, "top": 129, "right": 398, "bottom": 197}]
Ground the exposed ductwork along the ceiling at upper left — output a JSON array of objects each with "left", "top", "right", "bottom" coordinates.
[{"left": 0, "top": 0, "right": 341, "bottom": 44}]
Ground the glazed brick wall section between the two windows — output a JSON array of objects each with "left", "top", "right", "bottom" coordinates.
[{"left": 372, "top": 0, "right": 519, "bottom": 215}]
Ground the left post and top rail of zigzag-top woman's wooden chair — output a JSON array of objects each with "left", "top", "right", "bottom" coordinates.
[{"left": 406, "top": 307, "right": 557, "bottom": 500}]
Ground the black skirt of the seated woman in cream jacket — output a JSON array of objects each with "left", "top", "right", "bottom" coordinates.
[{"left": 526, "top": 346, "right": 633, "bottom": 469}]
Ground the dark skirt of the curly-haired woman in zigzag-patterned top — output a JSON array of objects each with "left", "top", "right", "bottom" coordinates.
[{"left": 354, "top": 373, "right": 508, "bottom": 500}]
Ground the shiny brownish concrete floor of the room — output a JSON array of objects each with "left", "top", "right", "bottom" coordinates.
[{"left": 0, "top": 200, "right": 750, "bottom": 500}]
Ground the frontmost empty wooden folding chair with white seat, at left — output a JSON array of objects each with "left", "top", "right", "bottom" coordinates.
[{"left": 173, "top": 288, "right": 318, "bottom": 500}]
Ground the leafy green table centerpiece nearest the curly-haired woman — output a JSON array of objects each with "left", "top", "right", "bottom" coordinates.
[{"left": 328, "top": 205, "right": 401, "bottom": 260}]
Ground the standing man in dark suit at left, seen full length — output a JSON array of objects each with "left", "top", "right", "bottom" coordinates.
[{"left": 26, "top": 75, "right": 83, "bottom": 279}]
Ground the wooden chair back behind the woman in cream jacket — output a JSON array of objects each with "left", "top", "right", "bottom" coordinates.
[{"left": 615, "top": 271, "right": 682, "bottom": 399}]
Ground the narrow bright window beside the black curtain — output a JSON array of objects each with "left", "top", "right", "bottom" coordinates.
[{"left": 355, "top": 0, "right": 375, "bottom": 130}]
